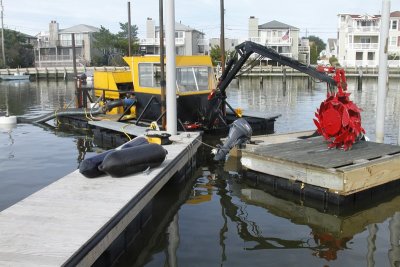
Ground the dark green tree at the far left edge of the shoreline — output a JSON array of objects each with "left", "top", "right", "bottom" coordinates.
[{"left": 0, "top": 29, "right": 34, "bottom": 68}]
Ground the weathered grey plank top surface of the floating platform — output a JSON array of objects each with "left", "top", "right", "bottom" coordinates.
[{"left": 253, "top": 137, "right": 400, "bottom": 168}]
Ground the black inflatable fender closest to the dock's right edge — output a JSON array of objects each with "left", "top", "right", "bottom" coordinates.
[{"left": 98, "top": 144, "right": 167, "bottom": 177}]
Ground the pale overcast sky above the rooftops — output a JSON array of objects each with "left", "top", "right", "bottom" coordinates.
[{"left": 2, "top": 0, "right": 400, "bottom": 41}]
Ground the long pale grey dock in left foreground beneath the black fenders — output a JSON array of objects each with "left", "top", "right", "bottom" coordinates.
[{"left": 0, "top": 133, "right": 201, "bottom": 266}]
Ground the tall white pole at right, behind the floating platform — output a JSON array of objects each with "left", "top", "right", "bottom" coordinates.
[{"left": 376, "top": 0, "right": 390, "bottom": 143}]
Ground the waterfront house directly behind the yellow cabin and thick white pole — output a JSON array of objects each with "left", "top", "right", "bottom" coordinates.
[{"left": 139, "top": 18, "right": 208, "bottom": 56}]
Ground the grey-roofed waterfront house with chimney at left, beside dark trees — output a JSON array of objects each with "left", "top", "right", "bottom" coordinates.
[{"left": 35, "top": 21, "right": 99, "bottom": 67}]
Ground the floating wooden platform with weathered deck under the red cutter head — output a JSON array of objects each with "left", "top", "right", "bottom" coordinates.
[{"left": 241, "top": 132, "right": 400, "bottom": 202}]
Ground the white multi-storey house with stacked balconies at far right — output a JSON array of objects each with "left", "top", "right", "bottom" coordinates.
[{"left": 337, "top": 11, "right": 400, "bottom": 67}]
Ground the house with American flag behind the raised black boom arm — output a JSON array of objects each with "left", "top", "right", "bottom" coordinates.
[{"left": 248, "top": 16, "right": 310, "bottom": 63}]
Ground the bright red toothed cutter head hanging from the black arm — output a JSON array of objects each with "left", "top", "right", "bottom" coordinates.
[{"left": 314, "top": 69, "right": 365, "bottom": 150}]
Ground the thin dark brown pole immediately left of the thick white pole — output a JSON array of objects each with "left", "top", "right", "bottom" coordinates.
[{"left": 159, "top": 0, "right": 167, "bottom": 129}]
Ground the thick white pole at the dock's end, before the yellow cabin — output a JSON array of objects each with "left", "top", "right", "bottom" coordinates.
[{"left": 165, "top": 0, "right": 177, "bottom": 135}]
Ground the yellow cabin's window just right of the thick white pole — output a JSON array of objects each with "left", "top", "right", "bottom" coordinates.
[{"left": 176, "top": 67, "right": 209, "bottom": 92}]
